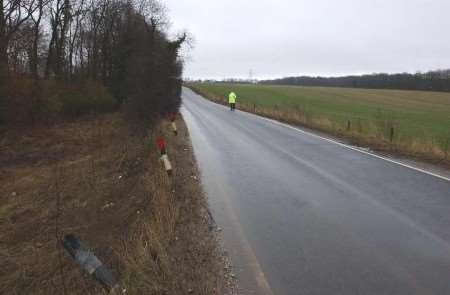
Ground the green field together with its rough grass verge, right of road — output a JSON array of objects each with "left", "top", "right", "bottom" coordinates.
[{"left": 188, "top": 83, "right": 450, "bottom": 166}]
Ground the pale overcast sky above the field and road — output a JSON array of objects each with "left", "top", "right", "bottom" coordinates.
[{"left": 163, "top": 0, "right": 450, "bottom": 79}]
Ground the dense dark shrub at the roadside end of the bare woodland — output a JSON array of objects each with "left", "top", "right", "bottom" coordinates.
[{"left": 111, "top": 9, "right": 186, "bottom": 129}]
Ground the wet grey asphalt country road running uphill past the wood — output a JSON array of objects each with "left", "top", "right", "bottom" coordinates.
[{"left": 182, "top": 88, "right": 450, "bottom": 295}]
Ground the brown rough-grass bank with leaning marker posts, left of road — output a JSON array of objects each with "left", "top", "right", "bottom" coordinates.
[{"left": 0, "top": 114, "right": 229, "bottom": 294}]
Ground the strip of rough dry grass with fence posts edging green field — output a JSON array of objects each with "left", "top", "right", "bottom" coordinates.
[{"left": 202, "top": 93, "right": 450, "bottom": 162}]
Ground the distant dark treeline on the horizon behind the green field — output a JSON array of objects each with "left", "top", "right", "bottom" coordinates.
[{"left": 260, "top": 70, "right": 450, "bottom": 92}]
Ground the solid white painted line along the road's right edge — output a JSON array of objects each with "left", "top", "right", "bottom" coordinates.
[{"left": 253, "top": 115, "right": 450, "bottom": 181}]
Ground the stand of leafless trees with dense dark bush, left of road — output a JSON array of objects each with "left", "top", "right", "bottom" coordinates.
[{"left": 0, "top": 0, "right": 186, "bottom": 123}]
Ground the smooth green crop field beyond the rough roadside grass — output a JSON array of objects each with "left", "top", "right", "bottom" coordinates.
[{"left": 193, "top": 83, "right": 450, "bottom": 156}]
